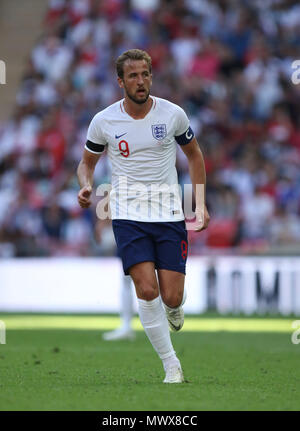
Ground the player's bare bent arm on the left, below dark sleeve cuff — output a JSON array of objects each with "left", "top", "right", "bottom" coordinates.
[{"left": 77, "top": 149, "right": 101, "bottom": 208}]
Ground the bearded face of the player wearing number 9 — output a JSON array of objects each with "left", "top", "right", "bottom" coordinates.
[{"left": 118, "top": 60, "right": 152, "bottom": 105}]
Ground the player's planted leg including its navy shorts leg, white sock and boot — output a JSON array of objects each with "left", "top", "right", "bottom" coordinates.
[{"left": 112, "top": 220, "right": 183, "bottom": 383}]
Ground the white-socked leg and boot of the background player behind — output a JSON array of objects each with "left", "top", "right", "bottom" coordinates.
[{"left": 103, "top": 274, "right": 135, "bottom": 341}]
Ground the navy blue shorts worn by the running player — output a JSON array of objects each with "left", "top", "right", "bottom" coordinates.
[{"left": 112, "top": 219, "right": 188, "bottom": 275}]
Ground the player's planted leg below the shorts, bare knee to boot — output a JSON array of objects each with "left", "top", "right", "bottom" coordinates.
[{"left": 129, "top": 262, "right": 183, "bottom": 383}]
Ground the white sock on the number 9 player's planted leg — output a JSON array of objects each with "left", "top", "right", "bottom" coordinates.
[{"left": 138, "top": 296, "right": 178, "bottom": 362}]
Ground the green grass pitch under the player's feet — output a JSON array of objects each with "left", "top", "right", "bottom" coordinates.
[{"left": 0, "top": 314, "right": 300, "bottom": 411}]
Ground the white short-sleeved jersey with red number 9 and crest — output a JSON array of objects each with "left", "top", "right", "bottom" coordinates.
[{"left": 85, "top": 96, "right": 192, "bottom": 222}]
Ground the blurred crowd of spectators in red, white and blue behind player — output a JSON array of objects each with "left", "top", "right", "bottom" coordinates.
[{"left": 0, "top": 0, "right": 300, "bottom": 257}]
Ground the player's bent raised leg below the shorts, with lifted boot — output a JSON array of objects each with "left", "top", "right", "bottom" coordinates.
[{"left": 157, "top": 269, "right": 186, "bottom": 331}]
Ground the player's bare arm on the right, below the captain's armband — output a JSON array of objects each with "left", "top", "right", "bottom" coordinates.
[{"left": 180, "top": 137, "right": 210, "bottom": 232}]
